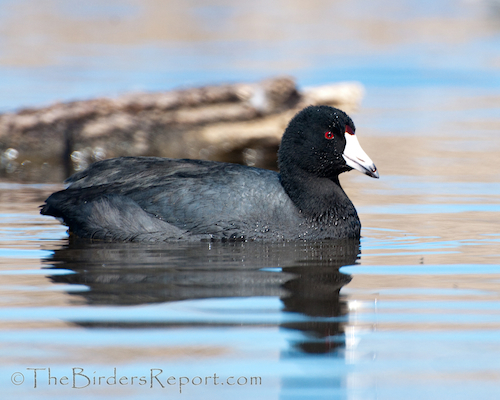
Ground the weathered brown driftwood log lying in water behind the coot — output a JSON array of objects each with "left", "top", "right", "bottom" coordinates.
[{"left": 0, "top": 77, "right": 363, "bottom": 182}]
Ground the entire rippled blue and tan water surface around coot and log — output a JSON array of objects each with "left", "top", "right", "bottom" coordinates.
[{"left": 0, "top": 0, "right": 500, "bottom": 400}]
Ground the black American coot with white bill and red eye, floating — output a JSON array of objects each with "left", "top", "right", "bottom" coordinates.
[{"left": 41, "top": 106, "right": 378, "bottom": 241}]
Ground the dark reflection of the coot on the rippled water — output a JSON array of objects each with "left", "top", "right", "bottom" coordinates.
[{"left": 44, "top": 239, "right": 360, "bottom": 353}]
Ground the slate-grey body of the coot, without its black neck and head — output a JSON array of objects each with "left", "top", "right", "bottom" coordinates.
[{"left": 42, "top": 157, "right": 297, "bottom": 240}]
